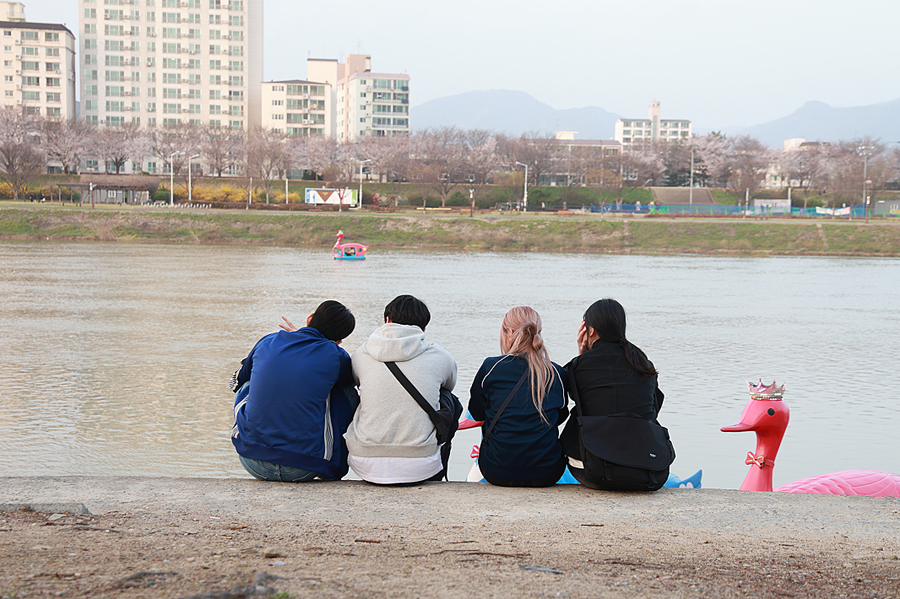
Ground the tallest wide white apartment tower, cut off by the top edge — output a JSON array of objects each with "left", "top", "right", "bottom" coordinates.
[{"left": 78, "top": 0, "right": 263, "bottom": 130}]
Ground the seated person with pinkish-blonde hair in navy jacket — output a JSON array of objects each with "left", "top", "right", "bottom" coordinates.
[{"left": 469, "top": 306, "right": 569, "bottom": 487}]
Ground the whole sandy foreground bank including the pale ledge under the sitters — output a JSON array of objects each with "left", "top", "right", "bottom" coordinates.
[{"left": 0, "top": 477, "right": 900, "bottom": 599}]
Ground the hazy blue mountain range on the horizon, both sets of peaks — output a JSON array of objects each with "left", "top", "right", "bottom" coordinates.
[{"left": 411, "top": 90, "right": 900, "bottom": 148}]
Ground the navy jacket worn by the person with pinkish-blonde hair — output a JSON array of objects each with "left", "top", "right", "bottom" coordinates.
[{"left": 469, "top": 355, "right": 569, "bottom": 482}]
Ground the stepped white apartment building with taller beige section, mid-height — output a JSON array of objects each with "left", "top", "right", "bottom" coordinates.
[{"left": 288, "top": 54, "right": 409, "bottom": 143}]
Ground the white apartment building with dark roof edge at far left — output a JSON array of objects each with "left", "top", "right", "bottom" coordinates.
[{"left": 0, "top": 2, "right": 75, "bottom": 119}]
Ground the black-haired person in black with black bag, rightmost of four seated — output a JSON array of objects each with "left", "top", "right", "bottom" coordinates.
[{"left": 560, "top": 299, "right": 675, "bottom": 491}]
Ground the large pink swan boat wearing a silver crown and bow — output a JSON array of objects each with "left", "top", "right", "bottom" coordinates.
[{"left": 722, "top": 380, "right": 900, "bottom": 497}]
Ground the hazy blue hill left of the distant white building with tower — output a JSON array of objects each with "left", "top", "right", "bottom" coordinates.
[{"left": 410, "top": 90, "right": 619, "bottom": 139}]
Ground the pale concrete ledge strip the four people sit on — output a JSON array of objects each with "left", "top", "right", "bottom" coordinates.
[{"left": 0, "top": 477, "right": 900, "bottom": 538}]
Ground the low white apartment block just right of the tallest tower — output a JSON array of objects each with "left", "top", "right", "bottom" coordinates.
[{"left": 262, "top": 79, "right": 334, "bottom": 137}]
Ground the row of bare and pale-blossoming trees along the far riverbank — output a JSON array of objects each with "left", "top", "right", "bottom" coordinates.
[{"left": 0, "top": 106, "right": 900, "bottom": 210}]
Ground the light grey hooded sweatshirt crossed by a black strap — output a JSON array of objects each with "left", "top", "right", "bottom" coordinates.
[{"left": 344, "top": 323, "right": 456, "bottom": 458}]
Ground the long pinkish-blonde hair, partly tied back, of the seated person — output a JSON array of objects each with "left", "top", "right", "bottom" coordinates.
[{"left": 500, "top": 306, "right": 556, "bottom": 422}]
